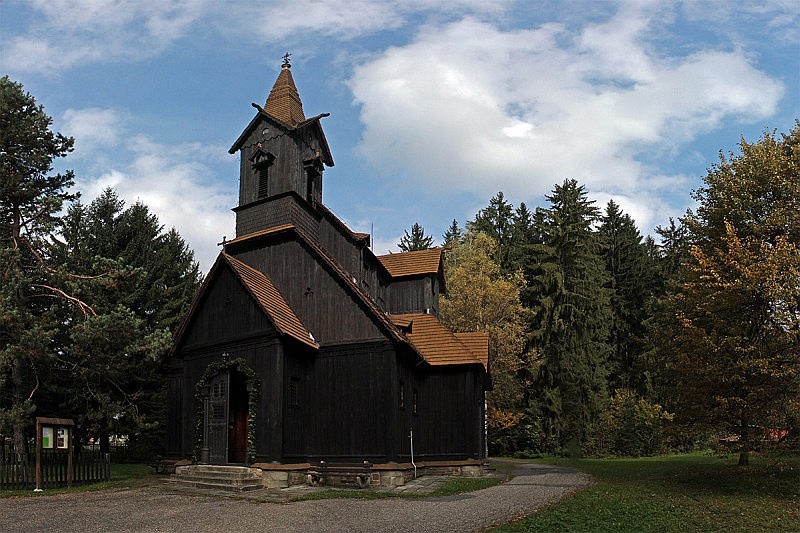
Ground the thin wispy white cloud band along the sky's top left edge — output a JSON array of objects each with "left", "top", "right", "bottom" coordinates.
[{"left": 0, "top": 0, "right": 506, "bottom": 74}]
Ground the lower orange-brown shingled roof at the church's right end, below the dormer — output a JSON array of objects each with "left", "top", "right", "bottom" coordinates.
[{"left": 389, "top": 313, "right": 488, "bottom": 366}]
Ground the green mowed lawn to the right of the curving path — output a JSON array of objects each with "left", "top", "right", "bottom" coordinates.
[{"left": 496, "top": 454, "right": 800, "bottom": 532}]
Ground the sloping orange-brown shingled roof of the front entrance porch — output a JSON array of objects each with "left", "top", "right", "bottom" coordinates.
[{"left": 222, "top": 253, "right": 318, "bottom": 348}]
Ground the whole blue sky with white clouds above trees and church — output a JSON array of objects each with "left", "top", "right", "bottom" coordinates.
[{"left": 0, "top": 0, "right": 800, "bottom": 269}]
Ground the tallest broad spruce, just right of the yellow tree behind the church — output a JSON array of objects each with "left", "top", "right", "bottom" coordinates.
[{"left": 523, "top": 180, "right": 610, "bottom": 454}]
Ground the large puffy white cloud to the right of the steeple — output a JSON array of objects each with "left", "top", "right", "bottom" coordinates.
[{"left": 349, "top": 3, "right": 784, "bottom": 225}]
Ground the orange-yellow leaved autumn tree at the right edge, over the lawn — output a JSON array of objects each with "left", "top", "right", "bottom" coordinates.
[{"left": 661, "top": 123, "right": 800, "bottom": 465}]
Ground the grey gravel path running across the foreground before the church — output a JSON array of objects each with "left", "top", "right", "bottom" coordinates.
[{"left": 0, "top": 464, "right": 589, "bottom": 533}]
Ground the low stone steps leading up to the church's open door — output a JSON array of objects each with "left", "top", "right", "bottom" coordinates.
[{"left": 166, "top": 465, "right": 264, "bottom": 492}]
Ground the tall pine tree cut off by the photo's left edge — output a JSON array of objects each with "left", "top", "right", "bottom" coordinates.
[{"left": 0, "top": 76, "right": 79, "bottom": 454}]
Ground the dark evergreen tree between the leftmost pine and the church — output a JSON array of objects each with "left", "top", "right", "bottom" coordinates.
[{"left": 50, "top": 189, "right": 200, "bottom": 446}]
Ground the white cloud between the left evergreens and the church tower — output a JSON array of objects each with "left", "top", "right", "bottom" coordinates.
[{"left": 77, "top": 136, "right": 236, "bottom": 271}]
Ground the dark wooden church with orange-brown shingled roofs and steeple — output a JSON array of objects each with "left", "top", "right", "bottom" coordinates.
[{"left": 165, "top": 56, "right": 490, "bottom": 465}]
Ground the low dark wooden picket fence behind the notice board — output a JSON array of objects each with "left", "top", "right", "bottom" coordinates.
[{"left": 0, "top": 445, "right": 111, "bottom": 490}]
